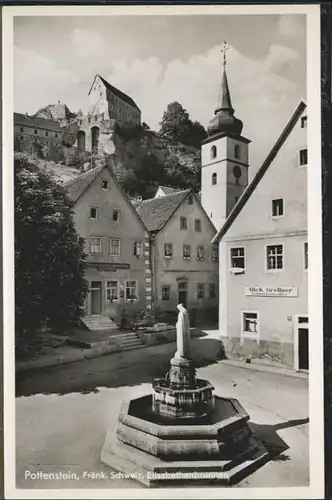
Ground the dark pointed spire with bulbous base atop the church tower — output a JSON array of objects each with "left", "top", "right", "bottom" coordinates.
[{"left": 208, "top": 41, "right": 243, "bottom": 135}]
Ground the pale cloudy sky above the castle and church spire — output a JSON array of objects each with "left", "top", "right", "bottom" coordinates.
[{"left": 14, "top": 14, "right": 306, "bottom": 169}]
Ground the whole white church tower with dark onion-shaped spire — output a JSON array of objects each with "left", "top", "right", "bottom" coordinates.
[{"left": 201, "top": 42, "right": 251, "bottom": 230}]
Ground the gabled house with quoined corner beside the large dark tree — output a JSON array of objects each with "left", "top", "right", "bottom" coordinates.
[{"left": 65, "top": 162, "right": 151, "bottom": 322}]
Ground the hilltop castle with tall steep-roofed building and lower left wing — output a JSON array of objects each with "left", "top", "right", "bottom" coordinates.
[{"left": 14, "top": 75, "right": 141, "bottom": 163}]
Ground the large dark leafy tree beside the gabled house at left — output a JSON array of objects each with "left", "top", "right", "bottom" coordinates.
[{"left": 14, "top": 153, "right": 87, "bottom": 338}]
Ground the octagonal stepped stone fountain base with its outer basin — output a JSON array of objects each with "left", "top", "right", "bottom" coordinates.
[{"left": 101, "top": 394, "right": 268, "bottom": 486}]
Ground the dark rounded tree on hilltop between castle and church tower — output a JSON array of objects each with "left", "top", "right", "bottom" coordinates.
[{"left": 160, "top": 102, "right": 207, "bottom": 148}]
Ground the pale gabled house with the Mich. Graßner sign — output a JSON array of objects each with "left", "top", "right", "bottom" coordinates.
[{"left": 214, "top": 102, "right": 309, "bottom": 370}]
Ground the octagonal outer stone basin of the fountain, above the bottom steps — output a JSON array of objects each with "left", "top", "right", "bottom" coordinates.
[{"left": 116, "top": 394, "right": 251, "bottom": 461}]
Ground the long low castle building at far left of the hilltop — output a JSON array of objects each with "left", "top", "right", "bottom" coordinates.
[{"left": 14, "top": 113, "right": 64, "bottom": 162}]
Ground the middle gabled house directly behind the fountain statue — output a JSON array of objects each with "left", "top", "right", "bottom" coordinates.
[{"left": 136, "top": 190, "right": 218, "bottom": 313}]
